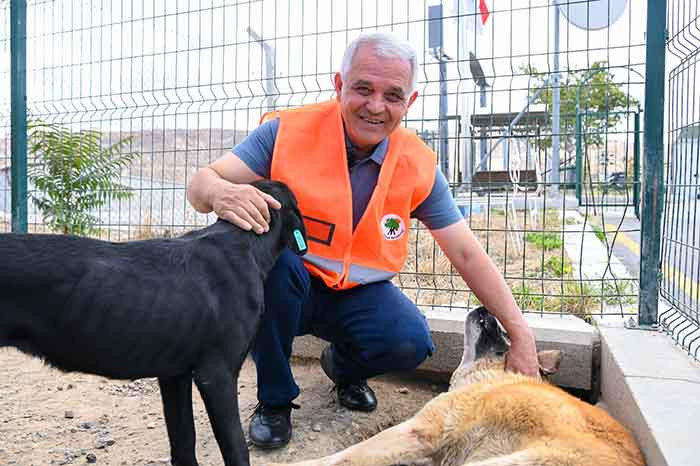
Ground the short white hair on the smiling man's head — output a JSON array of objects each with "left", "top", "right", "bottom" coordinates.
[{"left": 340, "top": 32, "right": 418, "bottom": 92}]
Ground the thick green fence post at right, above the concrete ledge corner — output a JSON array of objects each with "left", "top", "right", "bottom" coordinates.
[{"left": 639, "top": 0, "right": 666, "bottom": 328}]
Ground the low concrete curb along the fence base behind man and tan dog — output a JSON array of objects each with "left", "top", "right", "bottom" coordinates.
[{"left": 292, "top": 308, "right": 598, "bottom": 390}]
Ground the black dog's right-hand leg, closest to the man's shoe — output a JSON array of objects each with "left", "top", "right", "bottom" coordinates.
[{"left": 194, "top": 358, "right": 250, "bottom": 466}]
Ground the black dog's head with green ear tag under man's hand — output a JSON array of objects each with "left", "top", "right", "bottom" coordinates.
[{"left": 252, "top": 180, "right": 308, "bottom": 256}]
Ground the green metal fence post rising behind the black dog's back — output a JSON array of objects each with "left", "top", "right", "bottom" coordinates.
[{"left": 10, "top": 0, "right": 27, "bottom": 233}]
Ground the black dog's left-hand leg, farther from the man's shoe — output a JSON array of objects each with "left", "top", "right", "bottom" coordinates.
[{"left": 158, "top": 374, "right": 198, "bottom": 466}]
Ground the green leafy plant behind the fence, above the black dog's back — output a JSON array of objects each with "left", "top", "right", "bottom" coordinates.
[{"left": 28, "top": 121, "right": 139, "bottom": 235}]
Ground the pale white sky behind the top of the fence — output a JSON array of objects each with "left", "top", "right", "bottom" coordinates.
[{"left": 0, "top": 0, "right": 692, "bottom": 141}]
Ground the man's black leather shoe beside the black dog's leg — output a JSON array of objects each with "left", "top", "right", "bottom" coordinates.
[{"left": 248, "top": 403, "right": 299, "bottom": 450}]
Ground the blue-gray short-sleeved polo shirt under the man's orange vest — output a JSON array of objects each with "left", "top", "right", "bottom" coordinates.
[{"left": 233, "top": 118, "right": 462, "bottom": 230}]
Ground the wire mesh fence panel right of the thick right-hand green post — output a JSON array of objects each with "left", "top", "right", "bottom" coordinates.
[{"left": 659, "top": 0, "right": 700, "bottom": 359}]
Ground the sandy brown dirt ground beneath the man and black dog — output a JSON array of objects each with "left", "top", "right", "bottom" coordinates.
[{"left": 0, "top": 349, "right": 446, "bottom": 466}]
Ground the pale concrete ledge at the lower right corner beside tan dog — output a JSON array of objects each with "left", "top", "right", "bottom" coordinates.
[{"left": 599, "top": 325, "right": 700, "bottom": 466}]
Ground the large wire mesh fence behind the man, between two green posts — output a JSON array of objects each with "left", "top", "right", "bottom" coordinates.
[{"left": 0, "top": 0, "right": 648, "bottom": 317}]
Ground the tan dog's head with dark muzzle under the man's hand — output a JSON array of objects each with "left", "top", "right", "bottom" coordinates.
[{"left": 450, "top": 307, "right": 561, "bottom": 390}]
